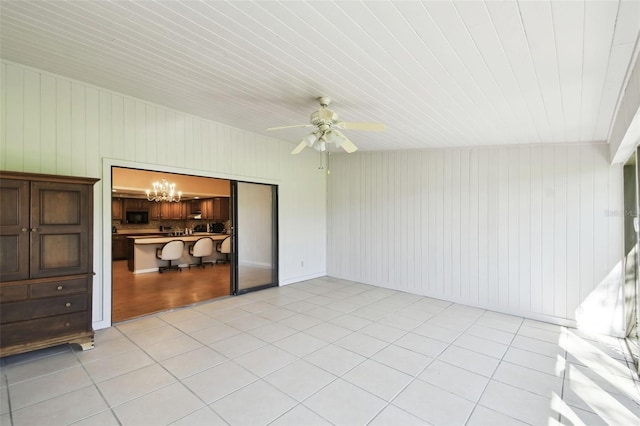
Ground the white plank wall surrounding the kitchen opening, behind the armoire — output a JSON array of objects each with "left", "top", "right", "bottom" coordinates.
[{"left": 0, "top": 61, "right": 326, "bottom": 328}]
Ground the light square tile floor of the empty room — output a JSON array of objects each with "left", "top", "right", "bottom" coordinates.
[{"left": 0, "top": 278, "right": 640, "bottom": 426}]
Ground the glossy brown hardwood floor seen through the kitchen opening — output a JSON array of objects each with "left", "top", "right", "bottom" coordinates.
[{"left": 111, "top": 260, "right": 230, "bottom": 323}]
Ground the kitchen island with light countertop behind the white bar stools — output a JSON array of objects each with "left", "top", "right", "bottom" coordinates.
[{"left": 127, "top": 232, "right": 229, "bottom": 274}]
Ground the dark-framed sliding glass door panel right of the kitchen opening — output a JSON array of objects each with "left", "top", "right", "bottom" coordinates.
[{"left": 231, "top": 181, "right": 278, "bottom": 294}]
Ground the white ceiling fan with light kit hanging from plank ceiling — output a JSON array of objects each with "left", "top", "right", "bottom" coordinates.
[{"left": 267, "top": 96, "right": 384, "bottom": 154}]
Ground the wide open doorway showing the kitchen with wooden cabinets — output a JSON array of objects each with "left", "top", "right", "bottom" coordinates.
[{"left": 111, "top": 166, "right": 233, "bottom": 323}]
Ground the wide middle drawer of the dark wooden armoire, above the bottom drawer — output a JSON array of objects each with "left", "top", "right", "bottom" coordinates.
[{"left": 0, "top": 294, "right": 87, "bottom": 324}]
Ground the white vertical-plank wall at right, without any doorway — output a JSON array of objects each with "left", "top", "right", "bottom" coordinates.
[{"left": 327, "top": 144, "right": 623, "bottom": 325}]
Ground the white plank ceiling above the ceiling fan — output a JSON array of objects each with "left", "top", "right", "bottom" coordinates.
[{"left": 0, "top": 0, "right": 640, "bottom": 151}]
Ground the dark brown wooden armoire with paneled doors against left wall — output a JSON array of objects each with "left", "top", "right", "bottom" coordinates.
[{"left": 0, "top": 171, "right": 98, "bottom": 356}]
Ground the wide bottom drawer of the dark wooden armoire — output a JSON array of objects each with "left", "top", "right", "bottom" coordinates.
[{"left": 0, "top": 312, "right": 88, "bottom": 347}]
